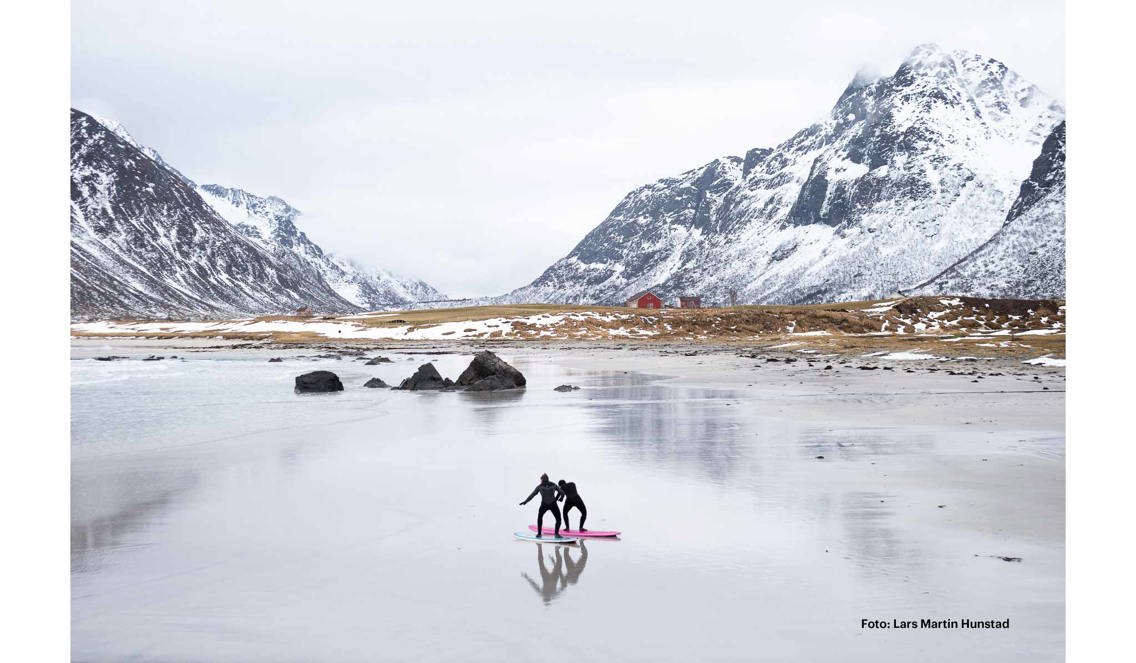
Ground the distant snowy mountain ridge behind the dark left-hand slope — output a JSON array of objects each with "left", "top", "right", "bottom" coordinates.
[{"left": 198, "top": 184, "right": 445, "bottom": 311}]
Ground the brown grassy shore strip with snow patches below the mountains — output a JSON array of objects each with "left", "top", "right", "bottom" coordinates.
[{"left": 70, "top": 297, "right": 1066, "bottom": 360}]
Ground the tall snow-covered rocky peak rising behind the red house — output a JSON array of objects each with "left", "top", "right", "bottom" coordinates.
[{"left": 498, "top": 45, "right": 1064, "bottom": 303}]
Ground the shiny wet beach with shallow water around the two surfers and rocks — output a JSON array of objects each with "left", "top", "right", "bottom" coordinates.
[{"left": 72, "top": 344, "right": 1064, "bottom": 662}]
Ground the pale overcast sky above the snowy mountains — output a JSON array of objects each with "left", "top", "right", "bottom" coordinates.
[{"left": 72, "top": 0, "right": 1064, "bottom": 296}]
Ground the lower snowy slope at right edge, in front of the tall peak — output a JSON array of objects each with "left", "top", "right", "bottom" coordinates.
[{"left": 916, "top": 123, "right": 1066, "bottom": 299}]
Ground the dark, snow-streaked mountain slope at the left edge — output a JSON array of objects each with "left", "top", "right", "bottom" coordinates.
[{"left": 70, "top": 109, "right": 433, "bottom": 318}]
